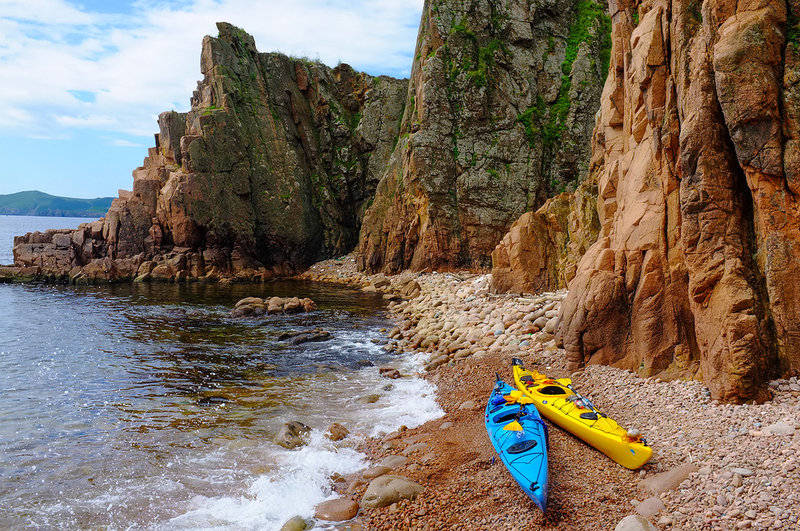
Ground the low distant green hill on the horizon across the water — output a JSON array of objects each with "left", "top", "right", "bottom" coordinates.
[{"left": 0, "top": 191, "right": 114, "bottom": 218}]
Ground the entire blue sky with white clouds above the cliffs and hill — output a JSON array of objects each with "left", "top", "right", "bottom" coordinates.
[{"left": 0, "top": 0, "right": 423, "bottom": 198}]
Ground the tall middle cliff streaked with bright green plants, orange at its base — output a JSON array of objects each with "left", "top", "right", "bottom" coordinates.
[{"left": 358, "top": 0, "right": 610, "bottom": 272}]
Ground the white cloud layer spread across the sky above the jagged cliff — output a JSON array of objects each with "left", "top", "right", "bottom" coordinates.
[{"left": 0, "top": 0, "right": 423, "bottom": 137}]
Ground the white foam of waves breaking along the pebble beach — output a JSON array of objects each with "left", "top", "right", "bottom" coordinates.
[{"left": 163, "top": 350, "right": 444, "bottom": 530}]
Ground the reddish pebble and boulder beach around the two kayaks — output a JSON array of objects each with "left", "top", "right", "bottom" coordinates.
[{"left": 286, "top": 256, "right": 800, "bottom": 530}]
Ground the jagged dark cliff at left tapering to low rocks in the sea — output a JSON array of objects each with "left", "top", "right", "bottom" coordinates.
[{"left": 14, "top": 23, "right": 407, "bottom": 281}]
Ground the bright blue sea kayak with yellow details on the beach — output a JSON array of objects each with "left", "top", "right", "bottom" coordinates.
[{"left": 485, "top": 376, "right": 548, "bottom": 511}]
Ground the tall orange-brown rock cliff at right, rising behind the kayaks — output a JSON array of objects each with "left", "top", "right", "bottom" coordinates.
[{"left": 558, "top": 0, "right": 800, "bottom": 401}]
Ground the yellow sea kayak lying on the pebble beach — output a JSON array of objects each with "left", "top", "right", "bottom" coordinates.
[{"left": 511, "top": 358, "right": 653, "bottom": 470}]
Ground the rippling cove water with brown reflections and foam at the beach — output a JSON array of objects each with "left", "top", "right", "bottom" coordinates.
[{"left": 0, "top": 281, "right": 442, "bottom": 529}]
